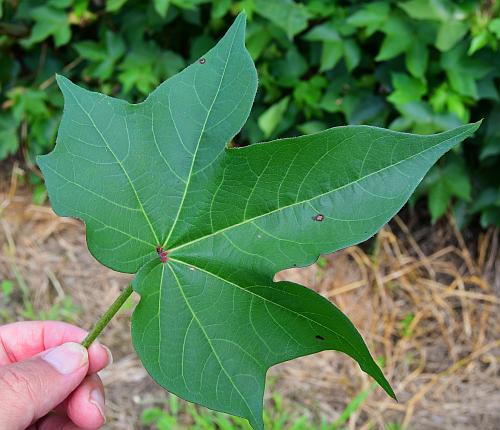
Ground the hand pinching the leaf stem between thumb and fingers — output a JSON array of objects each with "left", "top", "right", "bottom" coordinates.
[{"left": 0, "top": 321, "right": 111, "bottom": 430}]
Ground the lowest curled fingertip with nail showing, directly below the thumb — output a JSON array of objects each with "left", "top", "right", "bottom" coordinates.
[{"left": 66, "top": 375, "right": 106, "bottom": 430}]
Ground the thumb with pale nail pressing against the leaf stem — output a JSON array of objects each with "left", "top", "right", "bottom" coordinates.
[{"left": 0, "top": 342, "right": 89, "bottom": 430}]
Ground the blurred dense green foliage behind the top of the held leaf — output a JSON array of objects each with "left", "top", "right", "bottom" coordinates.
[{"left": 0, "top": 0, "right": 500, "bottom": 226}]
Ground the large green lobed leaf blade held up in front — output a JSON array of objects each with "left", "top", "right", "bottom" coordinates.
[{"left": 39, "top": 11, "right": 478, "bottom": 429}]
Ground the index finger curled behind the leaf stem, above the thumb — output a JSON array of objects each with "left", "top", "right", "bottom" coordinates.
[{"left": 0, "top": 321, "right": 111, "bottom": 373}]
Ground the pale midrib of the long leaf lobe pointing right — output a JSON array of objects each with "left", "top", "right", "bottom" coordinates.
[{"left": 169, "top": 129, "right": 470, "bottom": 253}]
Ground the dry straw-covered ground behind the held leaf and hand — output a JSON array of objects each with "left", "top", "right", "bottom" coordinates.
[{"left": 0, "top": 169, "right": 500, "bottom": 430}]
